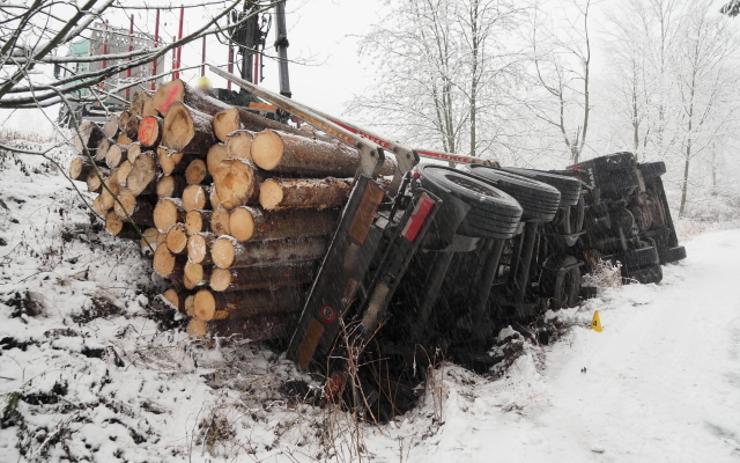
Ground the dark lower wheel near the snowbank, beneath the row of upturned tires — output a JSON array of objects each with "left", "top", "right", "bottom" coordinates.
[{"left": 540, "top": 255, "right": 581, "bottom": 310}]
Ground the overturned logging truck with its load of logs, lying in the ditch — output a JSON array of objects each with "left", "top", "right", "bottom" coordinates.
[{"left": 70, "top": 68, "right": 685, "bottom": 419}]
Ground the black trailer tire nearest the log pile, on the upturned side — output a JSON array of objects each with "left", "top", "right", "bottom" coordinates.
[{"left": 421, "top": 166, "right": 522, "bottom": 240}]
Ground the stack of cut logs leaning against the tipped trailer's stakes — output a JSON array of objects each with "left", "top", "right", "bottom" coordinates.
[{"left": 69, "top": 80, "right": 395, "bottom": 340}]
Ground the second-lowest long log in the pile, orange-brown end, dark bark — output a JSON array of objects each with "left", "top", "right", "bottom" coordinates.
[{"left": 193, "top": 286, "right": 303, "bottom": 321}]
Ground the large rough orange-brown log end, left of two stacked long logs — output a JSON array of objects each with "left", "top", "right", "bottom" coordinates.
[{"left": 213, "top": 159, "right": 258, "bottom": 209}]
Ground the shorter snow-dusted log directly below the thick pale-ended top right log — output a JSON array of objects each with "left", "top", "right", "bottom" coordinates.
[{"left": 259, "top": 177, "right": 353, "bottom": 210}]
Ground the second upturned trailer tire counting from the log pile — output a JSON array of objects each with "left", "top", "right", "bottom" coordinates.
[{"left": 471, "top": 166, "right": 560, "bottom": 222}]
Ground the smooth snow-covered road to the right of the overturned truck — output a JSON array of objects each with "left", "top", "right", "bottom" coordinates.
[{"left": 376, "top": 230, "right": 740, "bottom": 462}]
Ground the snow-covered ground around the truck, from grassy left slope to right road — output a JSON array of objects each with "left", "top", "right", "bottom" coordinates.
[{"left": 0, "top": 140, "right": 740, "bottom": 462}]
